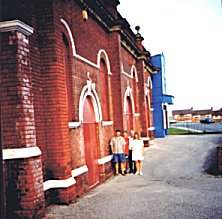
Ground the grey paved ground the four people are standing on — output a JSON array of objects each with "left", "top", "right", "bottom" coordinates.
[{"left": 47, "top": 135, "right": 222, "bottom": 219}]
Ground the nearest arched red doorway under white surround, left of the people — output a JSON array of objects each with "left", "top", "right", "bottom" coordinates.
[{"left": 83, "top": 96, "right": 99, "bottom": 187}]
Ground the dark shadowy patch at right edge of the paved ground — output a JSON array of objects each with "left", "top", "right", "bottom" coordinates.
[{"left": 203, "top": 148, "right": 222, "bottom": 176}]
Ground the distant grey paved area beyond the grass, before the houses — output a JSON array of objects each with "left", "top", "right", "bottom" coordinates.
[{"left": 171, "top": 122, "right": 222, "bottom": 133}]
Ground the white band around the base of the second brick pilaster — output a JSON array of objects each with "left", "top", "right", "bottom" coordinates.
[{"left": 43, "top": 177, "right": 76, "bottom": 191}]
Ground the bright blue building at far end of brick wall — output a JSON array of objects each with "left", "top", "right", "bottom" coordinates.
[{"left": 151, "top": 54, "right": 174, "bottom": 138}]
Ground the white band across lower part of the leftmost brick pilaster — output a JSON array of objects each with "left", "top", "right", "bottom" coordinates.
[{"left": 2, "top": 146, "right": 42, "bottom": 160}]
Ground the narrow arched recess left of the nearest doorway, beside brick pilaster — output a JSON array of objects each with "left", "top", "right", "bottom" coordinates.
[{"left": 62, "top": 33, "right": 74, "bottom": 121}]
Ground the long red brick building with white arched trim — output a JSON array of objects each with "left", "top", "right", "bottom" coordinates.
[{"left": 0, "top": 0, "right": 154, "bottom": 218}]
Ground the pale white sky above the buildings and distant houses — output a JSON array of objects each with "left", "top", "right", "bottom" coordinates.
[{"left": 118, "top": 0, "right": 222, "bottom": 110}]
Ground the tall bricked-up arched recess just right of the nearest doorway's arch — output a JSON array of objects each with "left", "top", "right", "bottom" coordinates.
[{"left": 100, "top": 59, "right": 110, "bottom": 121}]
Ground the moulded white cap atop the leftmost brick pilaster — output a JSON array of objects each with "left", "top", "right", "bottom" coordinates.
[{"left": 0, "top": 20, "right": 34, "bottom": 36}]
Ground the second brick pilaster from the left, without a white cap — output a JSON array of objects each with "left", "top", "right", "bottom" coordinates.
[{"left": 37, "top": 0, "right": 75, "bottom": 203}]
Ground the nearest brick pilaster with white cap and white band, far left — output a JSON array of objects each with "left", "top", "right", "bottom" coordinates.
[{"left": 0, "top": 20, "right": 44, "bottom": 218}]
